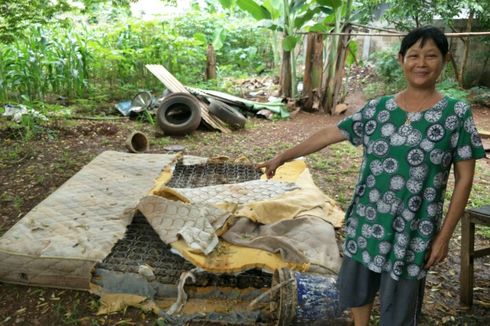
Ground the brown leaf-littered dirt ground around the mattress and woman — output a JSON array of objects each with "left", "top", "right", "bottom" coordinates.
[{"left": 0, "top": 94, "right": 490, "bottom": 325}]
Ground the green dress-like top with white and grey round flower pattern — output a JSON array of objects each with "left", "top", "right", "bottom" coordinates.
[{"left": 337, "top": 96, "right": 485, "bottom": 280}]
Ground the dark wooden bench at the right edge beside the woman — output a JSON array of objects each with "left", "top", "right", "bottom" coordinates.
[{"left": 460, "top": 205, "right": 490, "bottom": 307}]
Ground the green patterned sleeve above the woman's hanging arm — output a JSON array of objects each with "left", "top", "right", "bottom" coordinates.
[{"left": 454, "top": 101, "right": 485, "bottom": 162}]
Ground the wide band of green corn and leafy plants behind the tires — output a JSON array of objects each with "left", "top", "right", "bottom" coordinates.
[{"left": 0, "top": 12, "right": 273, "bottom": 103}]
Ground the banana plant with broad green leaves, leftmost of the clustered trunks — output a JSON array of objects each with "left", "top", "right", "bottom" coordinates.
[{"left": 219, "top": 0, "right": 342, "bottom": 97}]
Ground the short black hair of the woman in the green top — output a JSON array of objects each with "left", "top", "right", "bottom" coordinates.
[{"left": 398, "top": 26, "right": 449, "bottom": 57}]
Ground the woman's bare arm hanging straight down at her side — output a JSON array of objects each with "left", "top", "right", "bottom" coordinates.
[{"left": 425, "top": 160, "right": 475, "bottom": 269}]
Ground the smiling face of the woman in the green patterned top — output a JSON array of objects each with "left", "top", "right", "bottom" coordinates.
[{"left": 398, "top": 39, "right": 445, "bottom": 88}]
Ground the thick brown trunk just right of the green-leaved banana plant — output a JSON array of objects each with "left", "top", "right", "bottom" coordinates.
[{"left": 303, "top": 33, "right": 323, "bottom": 111}]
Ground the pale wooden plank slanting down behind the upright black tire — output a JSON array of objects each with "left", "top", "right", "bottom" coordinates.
[{"left": 145, "top": 65, "right": 231, "bottom": 133}]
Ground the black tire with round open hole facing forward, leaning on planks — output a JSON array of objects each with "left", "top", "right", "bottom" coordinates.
[{"left": 156, "top": 93, "right": 201, "bottom": 136}]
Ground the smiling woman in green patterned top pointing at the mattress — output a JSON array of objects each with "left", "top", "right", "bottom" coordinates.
[{"left": 258, "top": 26, "right": 485, "bottom": 326}]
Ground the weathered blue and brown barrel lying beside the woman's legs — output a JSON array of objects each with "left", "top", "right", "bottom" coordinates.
[{"left": 271, "top": 269, "right": 342, "bottom": 325}]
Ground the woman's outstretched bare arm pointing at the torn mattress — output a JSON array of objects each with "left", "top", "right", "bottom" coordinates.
[{"left": 257, "top": 125, "right": 347, "bottom": 179}]
